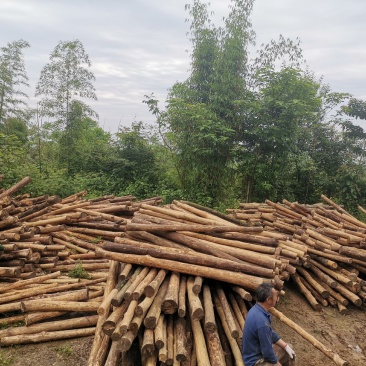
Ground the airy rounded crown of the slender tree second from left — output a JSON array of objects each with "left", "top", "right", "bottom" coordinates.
[{"left": 35, "top": 40, "right": 97, "bottom": 128}]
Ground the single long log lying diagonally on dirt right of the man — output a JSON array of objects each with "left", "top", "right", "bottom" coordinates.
[{"left": 269, "top": 307, "right": 349, "bottom": 366}]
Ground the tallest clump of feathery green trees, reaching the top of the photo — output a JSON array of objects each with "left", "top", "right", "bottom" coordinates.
[{"left": 146, "top": 0, "right": 301, "bottom": 206}]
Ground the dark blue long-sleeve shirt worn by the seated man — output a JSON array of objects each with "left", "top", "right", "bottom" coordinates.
[{"left": 242, "top": 303, "right": 280, "bottom": 366}]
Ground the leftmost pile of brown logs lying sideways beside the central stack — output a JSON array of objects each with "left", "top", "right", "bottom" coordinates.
[{"left": 0, "top": 178, "right": 161, "bottom": 345}]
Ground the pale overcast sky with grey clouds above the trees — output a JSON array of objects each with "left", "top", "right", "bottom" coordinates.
[{"left": 0, "top": 0, "right": 366, "bottom": 133}]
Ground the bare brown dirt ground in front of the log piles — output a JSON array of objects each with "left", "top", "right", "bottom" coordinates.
[{"left": 0, "top": 284, "right": 366, "bottom": 366}]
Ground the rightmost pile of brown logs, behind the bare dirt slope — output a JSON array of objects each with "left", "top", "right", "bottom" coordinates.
[{"left": 229, "top": 195, "right": 366, "bottom": 314}]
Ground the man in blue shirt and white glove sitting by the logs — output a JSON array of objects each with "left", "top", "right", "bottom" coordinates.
[{"left": 242, "top": 283, "right": 295, "bottom": 366}]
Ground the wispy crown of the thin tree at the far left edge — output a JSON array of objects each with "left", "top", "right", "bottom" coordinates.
[{"left": 0, "top": 39, "right": 30, "bottom": 126}]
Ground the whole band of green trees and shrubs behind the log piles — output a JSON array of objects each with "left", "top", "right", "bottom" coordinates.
[{"left": 0, "top": 0, "right": 366, "bottom": 212}]
